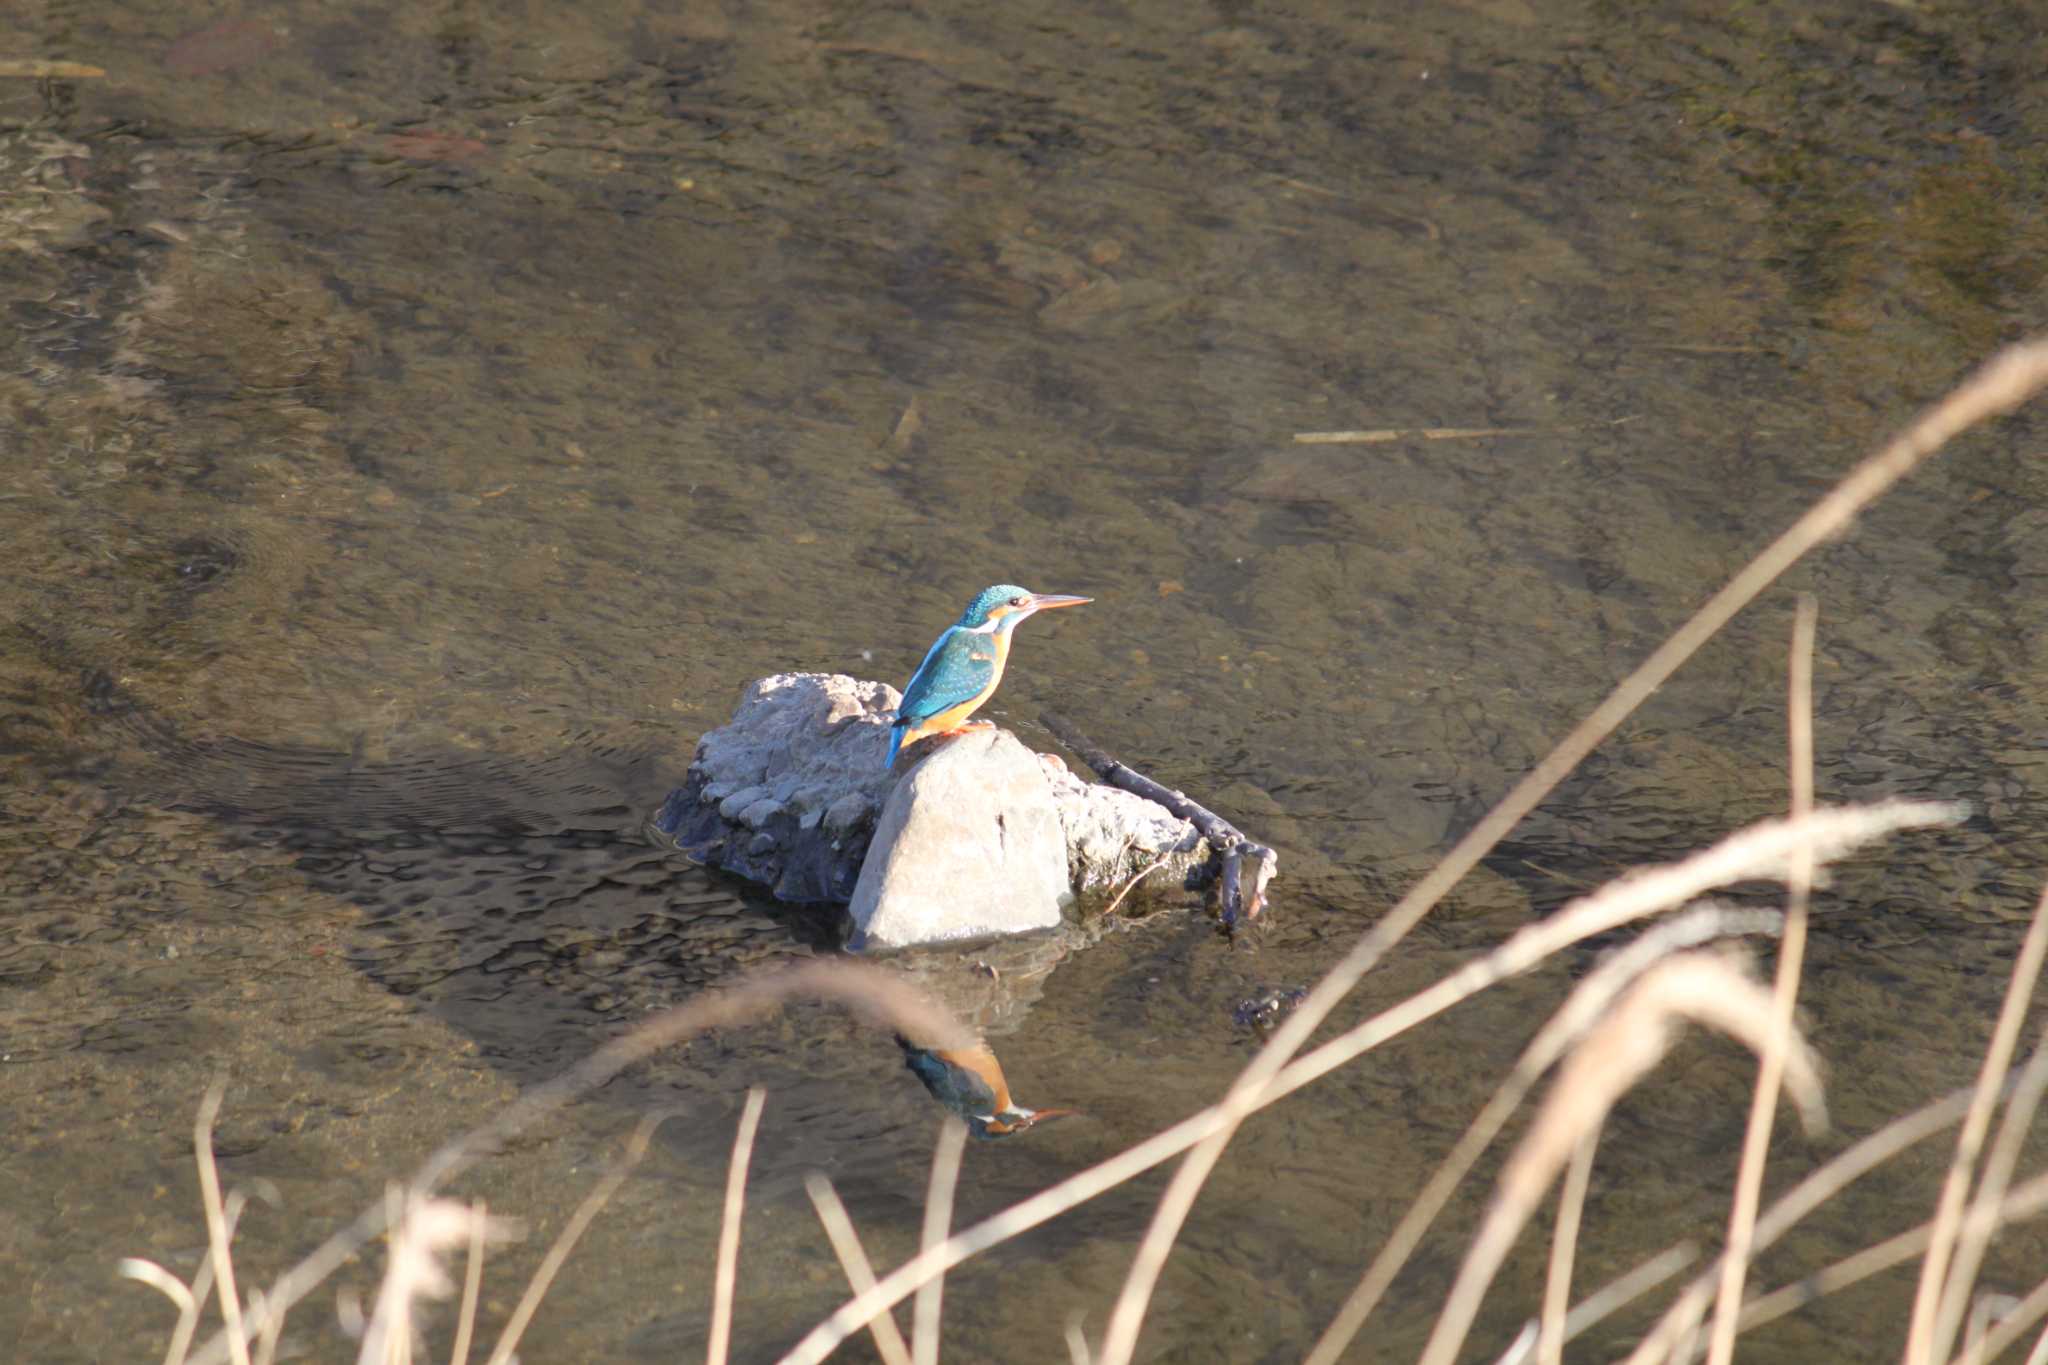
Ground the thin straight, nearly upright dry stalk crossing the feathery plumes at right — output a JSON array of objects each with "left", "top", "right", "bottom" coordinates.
[{"left": 1708, "top": 593, "right": 1819, "bottom": 1365}]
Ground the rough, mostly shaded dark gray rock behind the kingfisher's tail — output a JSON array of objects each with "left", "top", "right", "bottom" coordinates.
[{"left": 649, "top": 673, "right": 901, "bottom": 902}]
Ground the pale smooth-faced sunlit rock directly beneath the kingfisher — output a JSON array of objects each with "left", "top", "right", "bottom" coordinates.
[{"left": 848, "top": 729, "right": 1073, "bottom": 948}]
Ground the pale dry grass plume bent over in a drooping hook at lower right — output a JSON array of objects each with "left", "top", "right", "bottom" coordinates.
[{"left": 1421, "top": 952, "right": 1825, "bottom": 1365}]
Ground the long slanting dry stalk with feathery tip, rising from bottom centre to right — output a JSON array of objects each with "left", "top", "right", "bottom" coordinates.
[{"left": 782, "top": 800, "right": 1962, "bottom": 1365}]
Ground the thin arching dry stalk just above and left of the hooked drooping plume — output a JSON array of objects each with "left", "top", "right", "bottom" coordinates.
[{"left": 1307, "top": 905, "right": 1782, "bottom": 1365}]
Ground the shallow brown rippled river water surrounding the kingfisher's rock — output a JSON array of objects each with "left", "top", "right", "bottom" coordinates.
[{"left": 0, "top": 0, "right": 2048, "bottom": 1361}]
